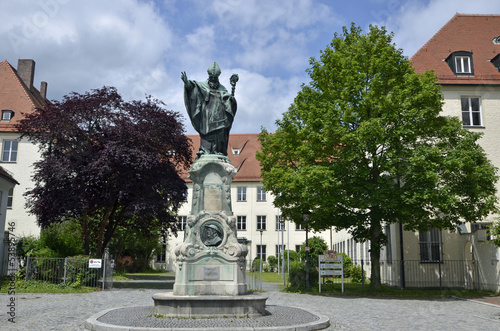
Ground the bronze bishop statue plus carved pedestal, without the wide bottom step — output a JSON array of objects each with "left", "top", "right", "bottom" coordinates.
[{"left": 173, "top": 62, "right": 248, "bottom": 296}]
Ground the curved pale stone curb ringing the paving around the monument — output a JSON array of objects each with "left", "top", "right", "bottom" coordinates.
[{"left": 85, "top": 306, "right": 330, "bottom": 331}]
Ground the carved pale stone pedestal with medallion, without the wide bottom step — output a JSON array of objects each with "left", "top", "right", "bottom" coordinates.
[{"left": 174, "top": 155, "right": 248, "bottom": 295}]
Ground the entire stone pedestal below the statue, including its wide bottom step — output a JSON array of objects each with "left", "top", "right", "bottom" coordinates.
[{"left": 153, "top": 155, "right": 267, "bottom": 317}]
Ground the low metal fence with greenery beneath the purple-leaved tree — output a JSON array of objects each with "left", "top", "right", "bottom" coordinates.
[{"left": 26, "top": 257, "right": 113, "bottom": 289}]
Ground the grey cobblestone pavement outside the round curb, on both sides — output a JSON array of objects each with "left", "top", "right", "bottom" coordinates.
[{"left": 0, "top": 284, "right": 500, "bottom": 331}]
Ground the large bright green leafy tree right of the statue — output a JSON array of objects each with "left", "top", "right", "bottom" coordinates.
[{"left": 257, "top": 25, "right": 497, "bottom": 288}]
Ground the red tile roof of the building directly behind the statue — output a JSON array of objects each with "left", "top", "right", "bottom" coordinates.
[{"left": 183, "top": 133, "right": 262, "bottom": 182}]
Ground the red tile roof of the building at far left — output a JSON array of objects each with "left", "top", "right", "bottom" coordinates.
[{"left": 0, "top": 61, "right": 49, "bottom": 132}]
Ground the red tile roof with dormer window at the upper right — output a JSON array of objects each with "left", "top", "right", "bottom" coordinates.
[{"left": 410, "top": 14, "right": 500, "bottom": 84}]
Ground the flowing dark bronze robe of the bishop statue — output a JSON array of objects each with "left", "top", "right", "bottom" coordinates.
[{"left": 184, "top": 81, "right": 237, "bottom": 155}]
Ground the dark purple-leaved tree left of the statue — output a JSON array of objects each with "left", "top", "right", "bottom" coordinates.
[{"left": 18, "top": 87, "right": 192, "bottom": 255}]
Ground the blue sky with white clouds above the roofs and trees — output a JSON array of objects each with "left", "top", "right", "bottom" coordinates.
[{"left": 0, "top": 0, "right": 500, "bottom": 134}]
